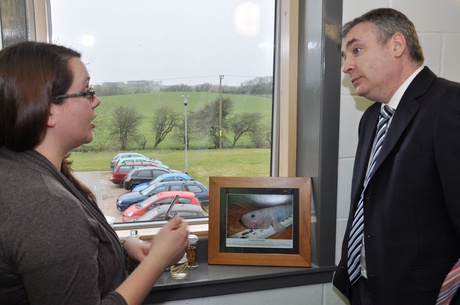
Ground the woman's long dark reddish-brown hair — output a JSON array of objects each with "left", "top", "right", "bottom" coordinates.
[{"left": 0, "top": 41, "right": 96, "bottom": 203}]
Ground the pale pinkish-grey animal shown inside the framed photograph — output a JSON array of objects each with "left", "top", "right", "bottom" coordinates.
[{"left": 241, "top": 204, "right": 292, "bottom": 233}]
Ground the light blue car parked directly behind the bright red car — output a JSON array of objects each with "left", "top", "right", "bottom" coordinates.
[{"left": 116, "top": 180, "right": 209, "bottom": 211}]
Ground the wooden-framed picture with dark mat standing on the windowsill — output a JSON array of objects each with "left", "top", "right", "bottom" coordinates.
[{"left": 208, "top": 177, "right": 311, "bottom": 267}]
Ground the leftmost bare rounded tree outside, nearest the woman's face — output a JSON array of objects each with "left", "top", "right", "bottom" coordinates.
[{"left": 111, "top": 106, "right": 142, "bottom": 150}]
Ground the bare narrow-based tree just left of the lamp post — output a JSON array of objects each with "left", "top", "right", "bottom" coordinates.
[{"left": 152, "top": 106, "right": 179, "bottom": 149}]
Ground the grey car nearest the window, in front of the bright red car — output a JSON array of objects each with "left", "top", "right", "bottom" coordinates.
[{"left": 131, "top": 203, "right": 208, "bottom": 221}]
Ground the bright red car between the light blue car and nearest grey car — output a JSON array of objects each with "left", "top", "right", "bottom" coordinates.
[{"left": 121, "top": 191, "right": 201, "bottom": 221}]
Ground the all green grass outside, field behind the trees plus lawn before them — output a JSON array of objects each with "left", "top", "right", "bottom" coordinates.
[{"left": 70, "top": 92, "right": 272, "bottom": 185}]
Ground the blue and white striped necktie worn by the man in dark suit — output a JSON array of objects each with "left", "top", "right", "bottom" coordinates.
[{"left": 347, "top": 105, "right": 395, "bottom": 285}]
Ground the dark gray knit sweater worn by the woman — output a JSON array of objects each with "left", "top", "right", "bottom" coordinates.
[{"left": 0, "top": 147, "right": 126, "bottom": 305}]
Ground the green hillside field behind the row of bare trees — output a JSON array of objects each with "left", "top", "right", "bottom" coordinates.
[{"left": 90, "top": 91, "right": 272, "bottom": 150}]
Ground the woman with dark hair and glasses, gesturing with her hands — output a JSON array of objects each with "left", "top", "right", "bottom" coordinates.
[{"left": 0, "top": 42, "right": 188, "bottom": 305}]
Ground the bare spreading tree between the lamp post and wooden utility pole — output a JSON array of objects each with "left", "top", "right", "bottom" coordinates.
[{"left": 190, "top": 98, "right": 232, "bottom": 148}]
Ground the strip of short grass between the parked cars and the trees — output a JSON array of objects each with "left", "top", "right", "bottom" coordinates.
[{"left": 70, "top": 149, "right": 270, "bottom": 186}]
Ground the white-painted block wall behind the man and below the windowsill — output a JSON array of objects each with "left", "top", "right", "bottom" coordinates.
[{"left": 149, "top": 0, "right": 460, "bottom": 305}]
